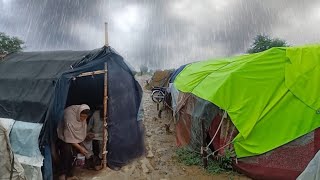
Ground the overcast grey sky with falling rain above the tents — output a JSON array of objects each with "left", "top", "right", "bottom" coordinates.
[{"left": 0, "top": 0, "right": 320, "bottom": 68}]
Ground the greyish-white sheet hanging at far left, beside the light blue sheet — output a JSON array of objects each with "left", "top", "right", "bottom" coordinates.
[{"left": 0, "top": 118, "right": 26, "bottom": 180}]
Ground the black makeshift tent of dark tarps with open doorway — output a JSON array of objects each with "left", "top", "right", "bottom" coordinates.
[{"left": 0, "top": 47, "right": 144, "bottom": 179}]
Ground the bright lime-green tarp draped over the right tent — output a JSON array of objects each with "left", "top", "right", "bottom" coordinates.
[{"left": 174, "top": 45, "right": 320, "bottom": 157}]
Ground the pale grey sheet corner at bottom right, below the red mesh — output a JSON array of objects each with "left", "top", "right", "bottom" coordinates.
[{"left": 297, "top": 151, "right": 320, "bottom": 180}]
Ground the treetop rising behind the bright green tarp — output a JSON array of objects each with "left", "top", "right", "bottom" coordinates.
[{"left": 247, "top": 35, "right": 289, "bottom": 54}]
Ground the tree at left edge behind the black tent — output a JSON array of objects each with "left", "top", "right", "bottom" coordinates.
[{"left": 0, "top": 32, "right": 24, "bottom": 54}]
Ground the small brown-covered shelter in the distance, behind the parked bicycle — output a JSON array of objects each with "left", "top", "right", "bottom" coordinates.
[{"left": 146, "top": 70, "right": 173, "bottom": 90}]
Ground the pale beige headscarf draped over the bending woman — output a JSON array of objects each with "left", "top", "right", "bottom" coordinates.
[{"left": 57, "top": 104, "right": 90, "bottom": 143}]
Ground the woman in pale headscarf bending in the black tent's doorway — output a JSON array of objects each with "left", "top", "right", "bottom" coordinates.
[{"left": 57, "top": 104, "right": 90, "bottom": 180}]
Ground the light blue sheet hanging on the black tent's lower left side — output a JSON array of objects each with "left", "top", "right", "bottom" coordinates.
[{"left": 10, "top": 121, "right": 43, "bottom": 167}]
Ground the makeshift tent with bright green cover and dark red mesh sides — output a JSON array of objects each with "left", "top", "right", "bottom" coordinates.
[{"left": 173, "top": 45, "right": 320, "bottom": 178}]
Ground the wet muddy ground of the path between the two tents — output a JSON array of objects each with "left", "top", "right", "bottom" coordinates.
[{"left": 76, "top": 76, "right": 248, "bottom": 180}]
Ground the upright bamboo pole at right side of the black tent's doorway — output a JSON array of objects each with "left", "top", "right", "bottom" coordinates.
[{"left": 102, "top": 63, "right": 108, "bottom": 168}]
